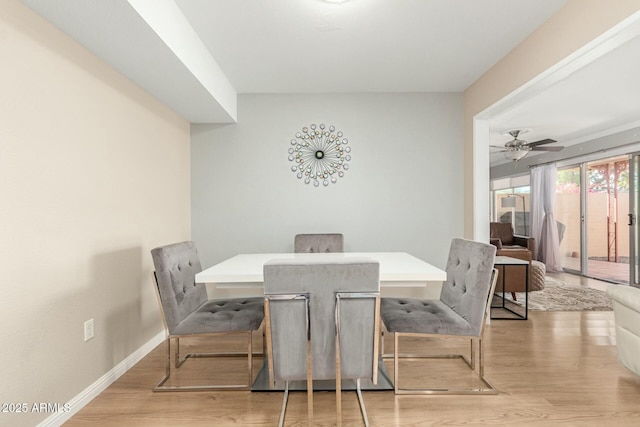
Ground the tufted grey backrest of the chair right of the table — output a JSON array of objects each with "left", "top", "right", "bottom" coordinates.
[{"left": 440, "top": 239, "right": 496, "bottom": 335}]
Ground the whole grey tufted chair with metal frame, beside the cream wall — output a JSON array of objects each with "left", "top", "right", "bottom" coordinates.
[{"left": 151, "top": 242, "right": 264, "bottom": 391}]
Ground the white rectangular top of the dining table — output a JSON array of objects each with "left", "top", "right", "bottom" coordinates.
[{"left": 196, "top": 252, "right": 447, "bottom": 283}]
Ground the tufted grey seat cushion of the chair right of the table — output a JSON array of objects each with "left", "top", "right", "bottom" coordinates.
[{"left": 380, "top": 298, "right": 475, "bottom": 336}]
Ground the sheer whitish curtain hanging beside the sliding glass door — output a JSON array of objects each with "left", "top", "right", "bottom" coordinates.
[{"left": 531, "top": 163, "right": 562, "bottom": 271}]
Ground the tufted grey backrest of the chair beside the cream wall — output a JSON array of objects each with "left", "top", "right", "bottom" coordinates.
[{"left": 151, "top": 242, "right": 207, "bottom": 334}]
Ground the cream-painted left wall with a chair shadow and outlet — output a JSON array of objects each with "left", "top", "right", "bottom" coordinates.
[{"left": 0, "top": 0, "right": 190, "bottom": 425}]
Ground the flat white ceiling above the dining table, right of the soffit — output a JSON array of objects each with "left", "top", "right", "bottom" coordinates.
[{"left": 176, "top": 0, "right": 565, "bottom": 93}]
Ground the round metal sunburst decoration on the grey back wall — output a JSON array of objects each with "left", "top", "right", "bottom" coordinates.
[{"left": 289, "top": 124, "right": 351, "bottom": 187}]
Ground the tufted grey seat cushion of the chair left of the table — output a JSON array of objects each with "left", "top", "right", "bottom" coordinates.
[{"left": 171, "top": 297, "right": 264, "bottom": 335}]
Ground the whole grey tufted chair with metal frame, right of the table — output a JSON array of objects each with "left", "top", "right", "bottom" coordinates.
[{"left": 380, "top": 239, "right": 497, "bottom": 394}]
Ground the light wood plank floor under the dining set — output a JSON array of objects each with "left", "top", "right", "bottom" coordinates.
[{"left": 65, "top": 276, "right": 640, "bottom": 426}]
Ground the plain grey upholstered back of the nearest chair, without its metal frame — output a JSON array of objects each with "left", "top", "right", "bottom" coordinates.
[{"left": 264, "top": 258, "right": 380, "bottom": 380}]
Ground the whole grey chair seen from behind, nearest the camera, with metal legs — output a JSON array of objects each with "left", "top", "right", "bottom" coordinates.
[{"left": 264, "top": 258, "right": 380, "bottom": 425}]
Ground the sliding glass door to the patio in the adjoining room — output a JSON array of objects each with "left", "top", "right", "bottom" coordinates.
[{"left": 554, "top": 155, "right": 640, "bottom": 283}]
